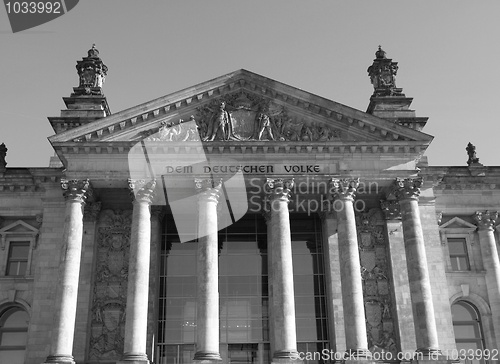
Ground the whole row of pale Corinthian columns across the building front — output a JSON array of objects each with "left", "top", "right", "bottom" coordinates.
[{"left": 45, "top": 178, "right": 500, "bottom": 364}]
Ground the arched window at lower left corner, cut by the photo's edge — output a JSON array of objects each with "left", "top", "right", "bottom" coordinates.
[{"left": 0, "top": 307, "right": 29, "bottom": 364}]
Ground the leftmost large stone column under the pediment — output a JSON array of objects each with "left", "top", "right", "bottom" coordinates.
[{"left": 45, "top": 180, "right": 90, "bottom": 364}]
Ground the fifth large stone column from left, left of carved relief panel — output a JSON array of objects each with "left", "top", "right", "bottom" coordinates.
[{"left": 330, "top": 179, "right": 370, "bottom": 360}]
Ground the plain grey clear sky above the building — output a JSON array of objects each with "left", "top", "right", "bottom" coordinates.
[{"left": 0, "top": 0, "right": 500, "bottom": 167}]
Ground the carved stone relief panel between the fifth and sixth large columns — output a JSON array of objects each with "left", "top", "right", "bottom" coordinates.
[{"left": 356, "top": 209, "right": 399, "bottom": 358}]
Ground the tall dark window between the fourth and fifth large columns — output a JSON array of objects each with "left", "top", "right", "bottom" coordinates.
[{"left": 290, "top": 214, "right": 328, "bottom": 363}]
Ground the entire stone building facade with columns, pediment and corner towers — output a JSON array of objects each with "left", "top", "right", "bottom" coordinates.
[{"left": 0, "top": 47, "right": 500, "bottom": 364}]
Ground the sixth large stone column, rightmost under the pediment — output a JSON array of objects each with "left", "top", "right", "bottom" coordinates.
[{"left": 394, "top": 178, "right": 440, "bottom": 357}]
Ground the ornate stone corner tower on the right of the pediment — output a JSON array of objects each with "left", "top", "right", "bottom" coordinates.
[{"left": 366, "top": 46, "right": 429, "bottom": 131}]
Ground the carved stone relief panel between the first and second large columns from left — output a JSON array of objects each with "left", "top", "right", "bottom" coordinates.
[{"left": 89, "top": 210, "right": 132, "bottom": 361}]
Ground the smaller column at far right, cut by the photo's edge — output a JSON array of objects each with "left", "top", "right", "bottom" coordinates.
[{"left": 474, "top": 211, "right": 500, "bottom": 348}]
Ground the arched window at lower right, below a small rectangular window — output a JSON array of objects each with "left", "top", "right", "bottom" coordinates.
[{"left": 451, "top": 301, "right": 484, "bottom": 364}]
